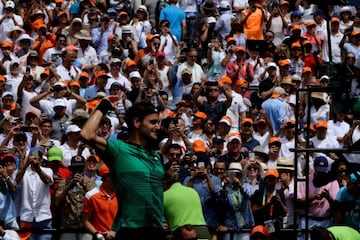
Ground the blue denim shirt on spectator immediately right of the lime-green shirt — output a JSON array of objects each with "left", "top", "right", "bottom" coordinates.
[{"left": 183, "top": 173, "right": 221, "bottom": 227}]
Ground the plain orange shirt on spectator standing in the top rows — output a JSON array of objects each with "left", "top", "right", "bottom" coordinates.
[{"left": 241, "top": 8, "right": 264, "bottom": 40}]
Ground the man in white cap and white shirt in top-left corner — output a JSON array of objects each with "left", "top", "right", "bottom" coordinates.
[{"left": 0, "top": 1, "right": 24, "bottom": 39}]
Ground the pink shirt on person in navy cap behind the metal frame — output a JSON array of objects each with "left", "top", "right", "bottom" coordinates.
[{"left": 297, "top": 173, "right": 339, "bottom": 218}]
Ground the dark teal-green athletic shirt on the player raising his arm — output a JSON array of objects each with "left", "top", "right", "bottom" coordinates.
[{"left": 103, "top": 140, "right": 164, "bottom": 231}]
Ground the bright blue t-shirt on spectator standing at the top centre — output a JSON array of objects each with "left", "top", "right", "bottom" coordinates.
[{"left": 160, "top": 4, "right": 185, "bottom": 41}]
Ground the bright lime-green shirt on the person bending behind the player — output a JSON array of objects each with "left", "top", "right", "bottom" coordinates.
[{"left": 164, "top": 182, "right": 206, "bottom": 232}]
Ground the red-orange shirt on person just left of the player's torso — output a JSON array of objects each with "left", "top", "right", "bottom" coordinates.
[{"left": 83, "top": 185, "right": 118, "bottom": 233}]
